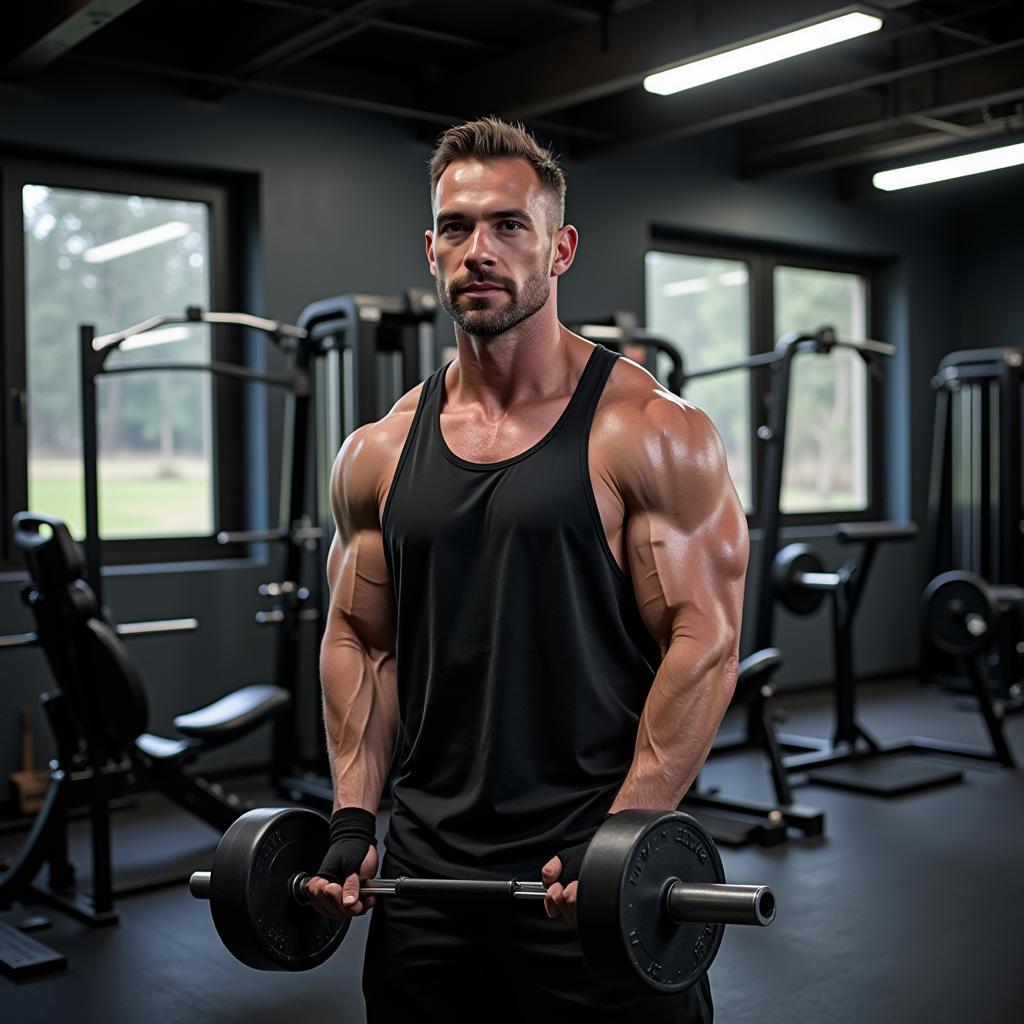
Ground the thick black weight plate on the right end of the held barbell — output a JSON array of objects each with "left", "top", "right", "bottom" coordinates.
[{"left": 577, "top": 810, "right": 725, "bottom": 993}]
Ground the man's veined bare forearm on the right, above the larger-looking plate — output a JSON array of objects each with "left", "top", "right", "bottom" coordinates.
[{"left": 611, "top": 639, "right": 738, "bottom": 811}]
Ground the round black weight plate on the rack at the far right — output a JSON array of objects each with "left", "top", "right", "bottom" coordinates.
[{"left": 922, "top": 569, "right": 999, "bottom": 657}]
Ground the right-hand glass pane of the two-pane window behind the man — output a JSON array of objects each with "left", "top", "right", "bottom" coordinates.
[{"left": 774, "top": 266, "right": 869, "bottom": 512}]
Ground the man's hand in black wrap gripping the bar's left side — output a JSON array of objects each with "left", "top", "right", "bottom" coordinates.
[{"left": 309, "top": 807, "right": 385, "bottom": 918}]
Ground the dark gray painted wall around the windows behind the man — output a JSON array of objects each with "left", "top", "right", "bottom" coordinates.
[{"left": 0, "top": 69, "right": 991, "bottom": 798}]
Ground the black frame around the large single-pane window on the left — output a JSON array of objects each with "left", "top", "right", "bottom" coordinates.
[{"left": 0, "top": 157, "right": 248, "bottom": 571}]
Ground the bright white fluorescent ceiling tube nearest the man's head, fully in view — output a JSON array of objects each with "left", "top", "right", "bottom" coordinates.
[{"left": 643, "top": 12, "right": 882, "bottom": 96}]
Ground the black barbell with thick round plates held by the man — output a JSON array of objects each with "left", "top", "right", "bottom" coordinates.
[{"left": 188, "top": 808, "right": 775, "bottom": 992}]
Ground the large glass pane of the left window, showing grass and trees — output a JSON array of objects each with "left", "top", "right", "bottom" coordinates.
[{"left": 22, "top": 184, "right": 213, "bottom": 538}]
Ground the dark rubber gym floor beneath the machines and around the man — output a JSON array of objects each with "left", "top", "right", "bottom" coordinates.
[{"left": 0, "top": 681, "right": 1024, "bottom": 1024}]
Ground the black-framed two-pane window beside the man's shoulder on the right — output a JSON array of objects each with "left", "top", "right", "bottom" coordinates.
[{"left": 646, "top": 240, "right": 880, "bottom": 519}]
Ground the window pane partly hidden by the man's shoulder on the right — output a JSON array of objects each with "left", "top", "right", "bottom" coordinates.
[{"left": 646, "top": 252, "right": 753, "bottom": 511}]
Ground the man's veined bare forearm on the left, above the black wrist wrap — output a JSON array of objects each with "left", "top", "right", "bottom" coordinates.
[{"left": 321, "top": 637, "right": 398, "bottom": 814}]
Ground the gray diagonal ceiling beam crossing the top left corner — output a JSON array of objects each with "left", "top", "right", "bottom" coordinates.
[{"left": 0, "top": 0, "right": 141, "bottom": 78}]
